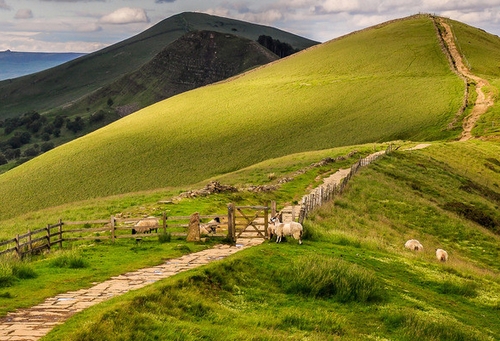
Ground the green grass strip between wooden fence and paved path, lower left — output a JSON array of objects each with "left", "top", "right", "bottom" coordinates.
[{"left": 0, "top": 237, "right": 213, "bottom": 315}]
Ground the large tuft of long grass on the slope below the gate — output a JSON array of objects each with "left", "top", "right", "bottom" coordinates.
[{"left": 278, "top": 255, "right": 383, "bottom": 302}]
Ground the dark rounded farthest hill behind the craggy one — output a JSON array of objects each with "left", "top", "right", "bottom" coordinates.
[{"left": 0, "top": 12, "right": 317, "bottom": 119}]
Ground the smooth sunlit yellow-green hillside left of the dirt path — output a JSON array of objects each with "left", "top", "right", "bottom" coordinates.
[{"left": 0, "top": 16, "right": 463, "bottom": 217}]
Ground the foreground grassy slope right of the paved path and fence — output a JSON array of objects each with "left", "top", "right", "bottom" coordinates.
[{"left": 42, "top": 141, "right": 500, "bottom": 341}]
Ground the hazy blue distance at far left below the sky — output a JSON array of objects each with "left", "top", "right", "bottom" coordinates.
[{"left": 0, "top": 50, "right": 85, "bottom": 81}]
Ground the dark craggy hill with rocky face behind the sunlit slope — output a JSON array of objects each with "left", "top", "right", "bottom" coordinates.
[{"left": 64, "top": 31, "right": 279, "bottom": 117}]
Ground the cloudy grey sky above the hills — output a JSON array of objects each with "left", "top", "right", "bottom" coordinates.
[{"left": 0, "top": 0, "right": 500, "bottom": 53}]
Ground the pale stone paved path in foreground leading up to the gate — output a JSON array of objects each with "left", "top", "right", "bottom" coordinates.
[{"left": 0, "top": 238, "right": 264, "bottom": 341}]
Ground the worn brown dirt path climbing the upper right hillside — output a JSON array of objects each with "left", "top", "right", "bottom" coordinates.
[{"left": 440, "top": 19, "right": 494, "bottom": 141}]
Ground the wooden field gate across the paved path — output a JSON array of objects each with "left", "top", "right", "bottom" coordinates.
[{"left": 227, "top": 204, "right": 270, "bottom": 242}]
